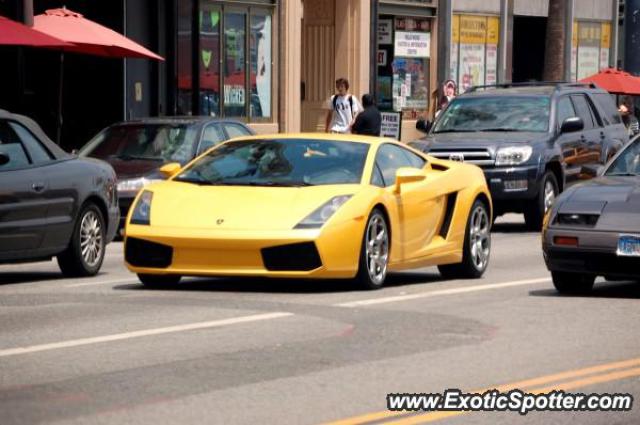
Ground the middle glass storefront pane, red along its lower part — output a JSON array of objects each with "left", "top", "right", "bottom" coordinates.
[{"left": 224, "top": 13, "right": 247, "bottom": 117}]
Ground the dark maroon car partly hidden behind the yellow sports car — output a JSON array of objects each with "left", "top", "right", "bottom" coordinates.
[{"left": 78, "top": 116, "right": 254, "bottom": 229}]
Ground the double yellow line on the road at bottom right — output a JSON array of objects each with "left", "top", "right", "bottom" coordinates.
[{"left": 325, "top": 357, "right": 640, "bottom": 425}]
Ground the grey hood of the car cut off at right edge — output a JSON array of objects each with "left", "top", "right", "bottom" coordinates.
[{"left": 558, "top": 176, "right": 640, "bottom": 233}]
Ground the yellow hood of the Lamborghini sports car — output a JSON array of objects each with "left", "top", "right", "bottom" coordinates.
[{"left": 148, "top": 181, "right": 362, "bottom": 230}]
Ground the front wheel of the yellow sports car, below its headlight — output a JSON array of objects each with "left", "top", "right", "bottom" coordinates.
[{"left": 356, "top": 209, "right": 390, "bottom": 289}]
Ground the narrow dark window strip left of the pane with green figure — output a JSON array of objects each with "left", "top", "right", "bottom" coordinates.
[{"left": 176, "top": 0, "right": 193, "bottom": 115}]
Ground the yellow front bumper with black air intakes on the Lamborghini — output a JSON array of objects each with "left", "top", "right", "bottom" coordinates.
[{"left": 125, "top": 220, "right": 364, "bottom": 278}]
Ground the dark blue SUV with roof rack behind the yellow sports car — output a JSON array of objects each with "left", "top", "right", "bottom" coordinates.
[{"left": 410, "top": 83, "right": 629, "bottom": 229}]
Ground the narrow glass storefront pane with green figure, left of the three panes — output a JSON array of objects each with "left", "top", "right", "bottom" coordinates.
[{"left": 198, "top": 1, "right": 220, "bottom": 116}]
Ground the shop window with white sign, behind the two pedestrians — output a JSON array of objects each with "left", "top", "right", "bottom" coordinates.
[{"left": 376, "top": 15, "right": 431, "bottom": 118}]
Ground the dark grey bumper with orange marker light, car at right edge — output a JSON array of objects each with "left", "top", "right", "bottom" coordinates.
[{"left": 542, "top": 227, "right": 640, "bottom": 279}]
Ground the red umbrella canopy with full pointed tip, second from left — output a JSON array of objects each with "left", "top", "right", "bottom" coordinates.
[{"left": 33, "top": 8, "right": 164, "bottom": 60}]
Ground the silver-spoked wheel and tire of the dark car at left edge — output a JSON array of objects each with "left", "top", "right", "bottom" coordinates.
[{"left": 57, "top": 203, "right": 107, "bottom": 277}]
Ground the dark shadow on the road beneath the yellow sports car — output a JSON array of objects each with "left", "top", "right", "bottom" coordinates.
[{"left": 113, "top": 272, "right": 442, "bottom": 294}]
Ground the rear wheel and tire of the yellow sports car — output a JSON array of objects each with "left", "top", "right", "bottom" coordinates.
[{"left": 438, "top": 199, "right": 491, "bottom": 279}]
